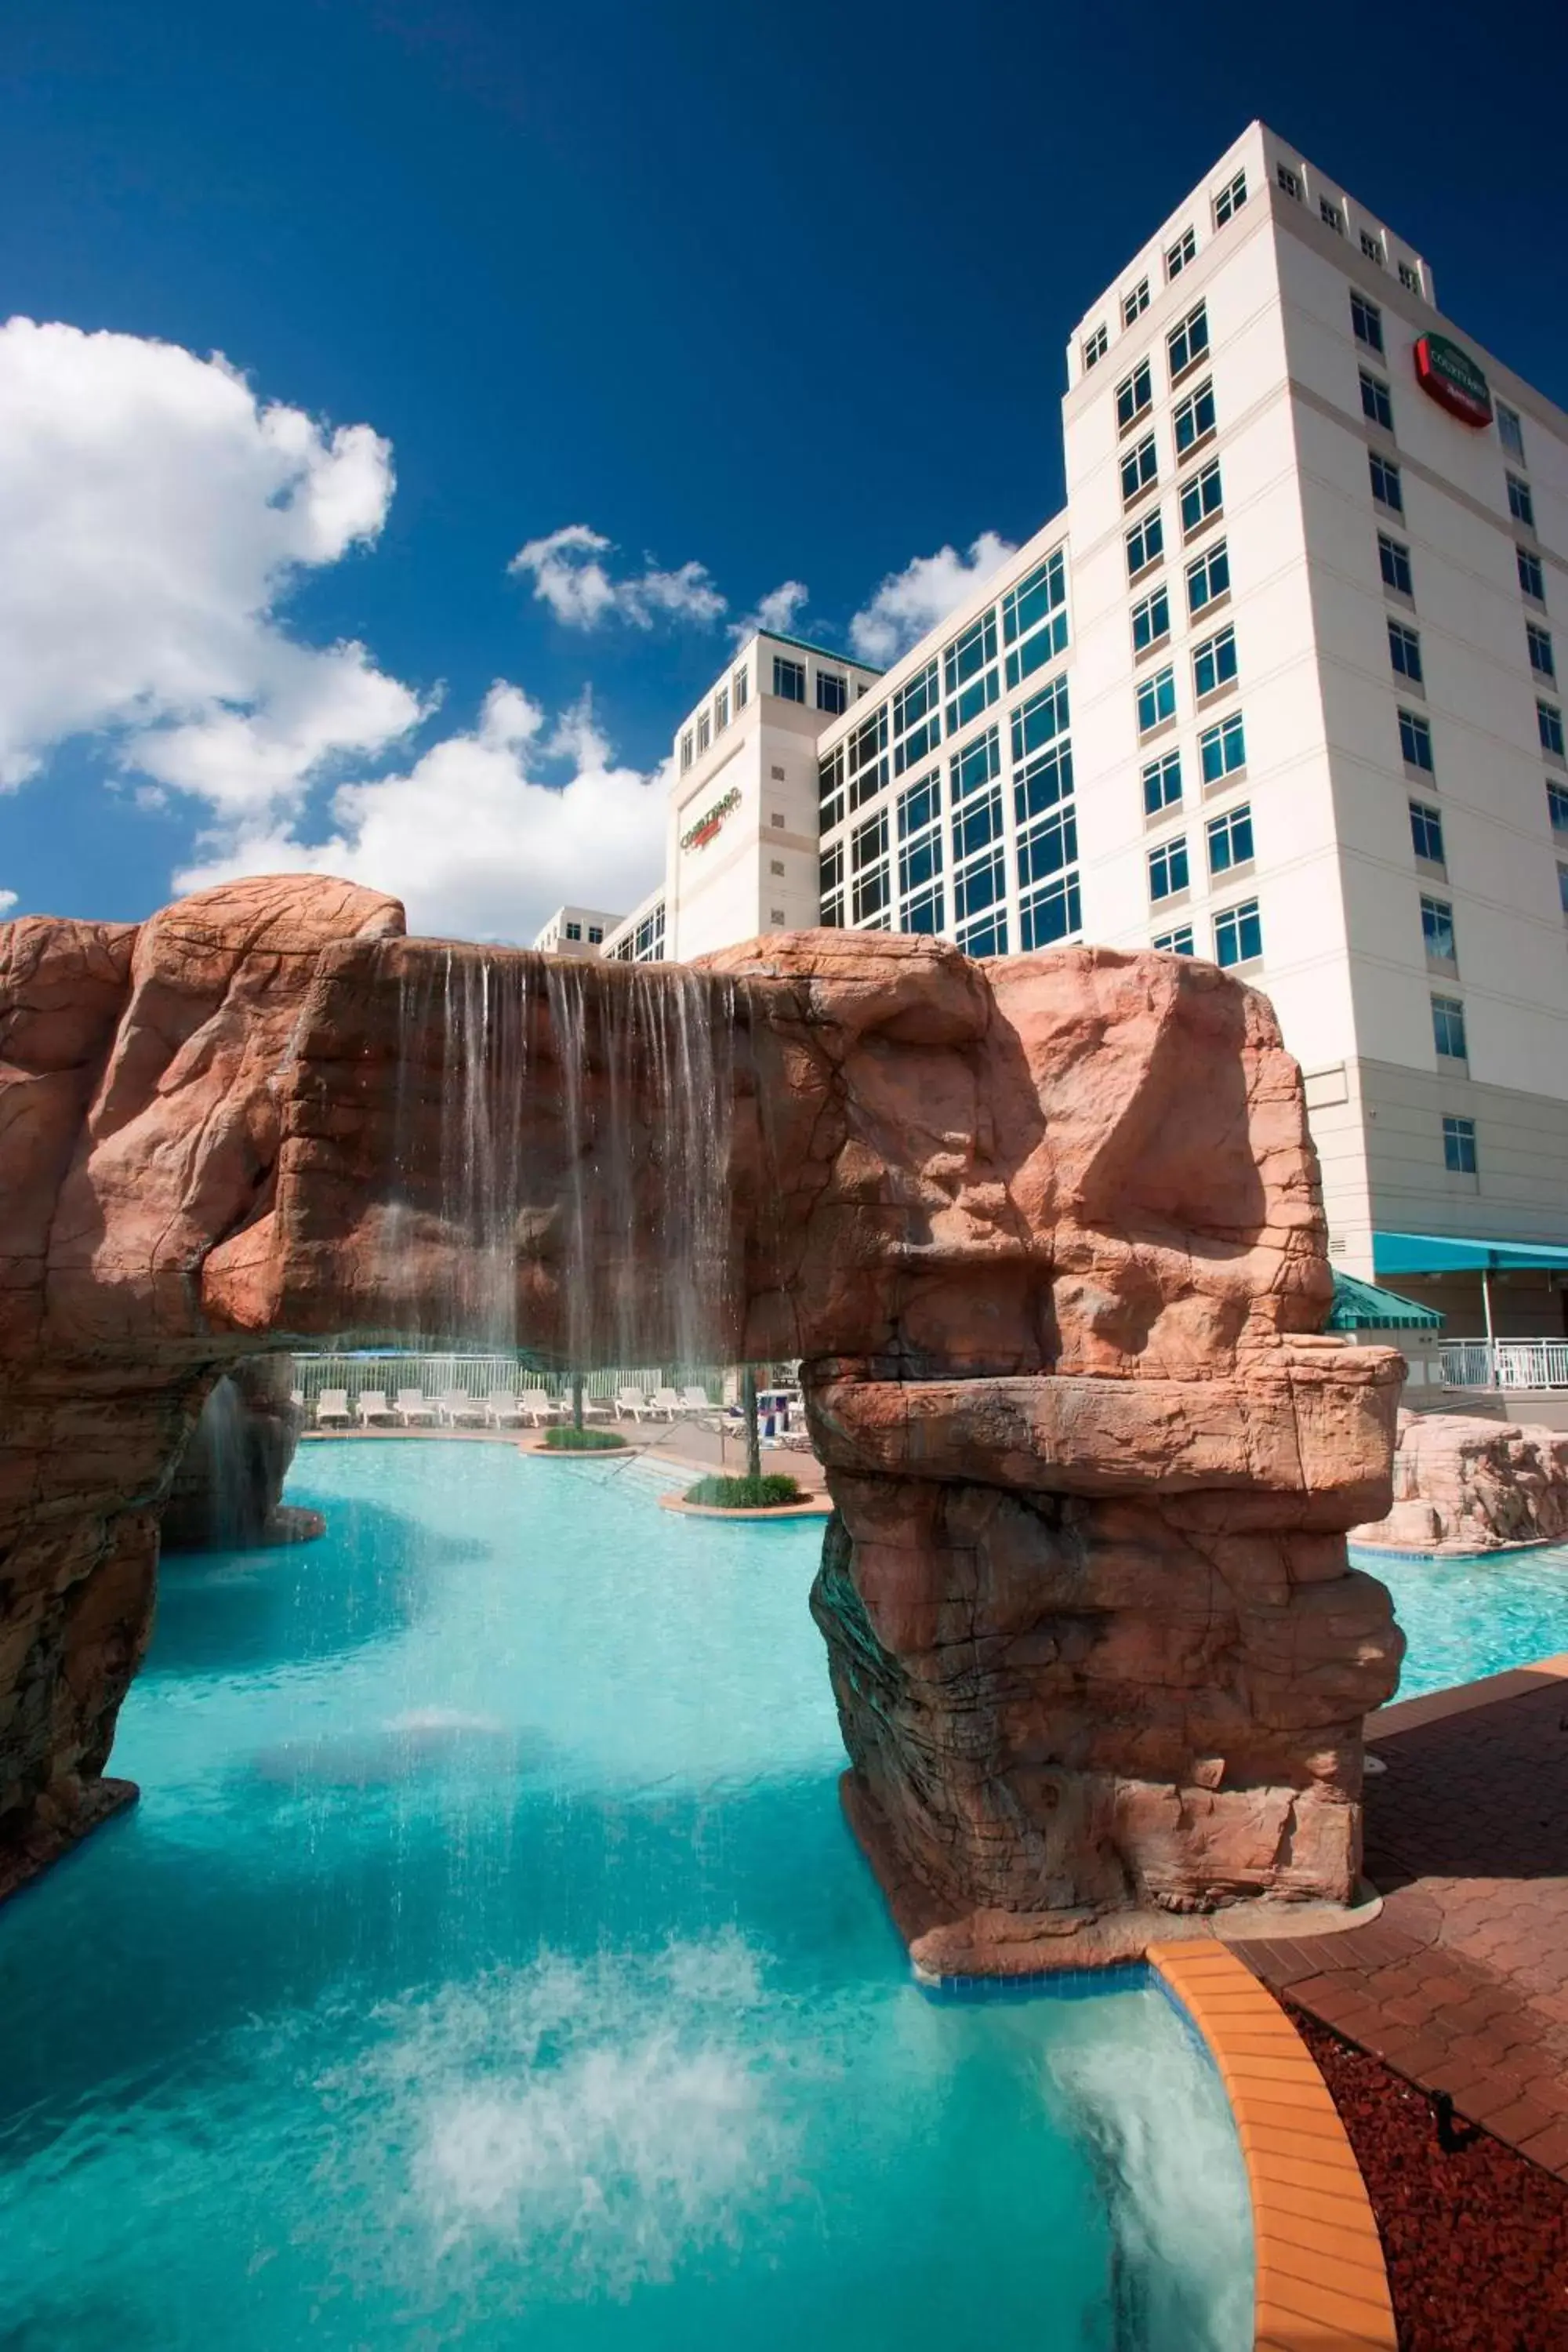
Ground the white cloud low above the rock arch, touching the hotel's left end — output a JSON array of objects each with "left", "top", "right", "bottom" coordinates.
[{"left": 176, "top": 680, "right": 666, "bottom": 943}]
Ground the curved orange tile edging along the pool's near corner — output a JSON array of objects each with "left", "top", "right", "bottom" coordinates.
[{"left": 1145, "top": 1940, "right": 1399, "bottom": 2352}]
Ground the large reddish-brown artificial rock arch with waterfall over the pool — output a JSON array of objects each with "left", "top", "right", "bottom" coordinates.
[{"left": 0, "top": 877, "right": 1401, "bottom": 1964}]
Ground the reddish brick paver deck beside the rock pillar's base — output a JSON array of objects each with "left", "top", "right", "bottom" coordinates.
[{"left": 1236, "top": 1661, "right": 1568, "bottom": 2180}]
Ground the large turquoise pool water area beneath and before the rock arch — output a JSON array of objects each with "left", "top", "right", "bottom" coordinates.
[{"left": 0, "top": 1442, "right": 1250, "bottom": 2352}]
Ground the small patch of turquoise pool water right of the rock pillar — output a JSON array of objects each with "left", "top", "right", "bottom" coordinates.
[{"left": 1349, "top": 1545, "right": 1568, "bottom": 1698}]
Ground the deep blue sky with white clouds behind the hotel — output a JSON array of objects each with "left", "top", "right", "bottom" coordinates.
[{"left": 0, "top": 0, "right": 1568, "bottom": 936}]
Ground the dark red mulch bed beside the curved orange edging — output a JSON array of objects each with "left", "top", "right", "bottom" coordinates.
[{"left": 1290, "top": 2009, "right": 1568, "bottom": 2352}]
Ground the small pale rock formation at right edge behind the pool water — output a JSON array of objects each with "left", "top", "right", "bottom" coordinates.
[{"left": 1352, "top": 1414, "right": 1568, "bottom": 1559}]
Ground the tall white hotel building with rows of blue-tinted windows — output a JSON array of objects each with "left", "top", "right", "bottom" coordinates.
[{"left": 545, "top": 122, "right": 1568, "bottom": 1336}]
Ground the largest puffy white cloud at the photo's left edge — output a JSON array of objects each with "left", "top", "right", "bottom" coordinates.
[{"left": 0, "top": 318, "right": 423, "bottom": 823}]
